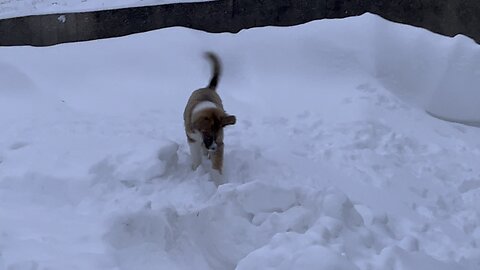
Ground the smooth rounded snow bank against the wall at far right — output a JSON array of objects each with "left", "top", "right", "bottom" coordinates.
[{"left": 364, "top": 18, "right": 480, "bottom": 124}]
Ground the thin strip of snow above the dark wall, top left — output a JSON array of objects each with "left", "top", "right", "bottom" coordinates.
[{"left": 0, "top": 0, "right": 210, "bottom": 19}]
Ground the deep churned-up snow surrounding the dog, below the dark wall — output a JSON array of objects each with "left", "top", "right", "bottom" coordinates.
[{"left": 0, "top": 14, "right": 480, "bottom": 270}]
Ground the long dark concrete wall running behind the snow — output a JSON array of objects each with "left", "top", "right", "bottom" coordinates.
[{"left": 0, "top": 0, "right": 480, "bottom": 46}]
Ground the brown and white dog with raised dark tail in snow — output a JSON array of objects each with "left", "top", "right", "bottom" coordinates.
[{"left": 183, "top": 52, "right": 236, "bottom": 174}]
